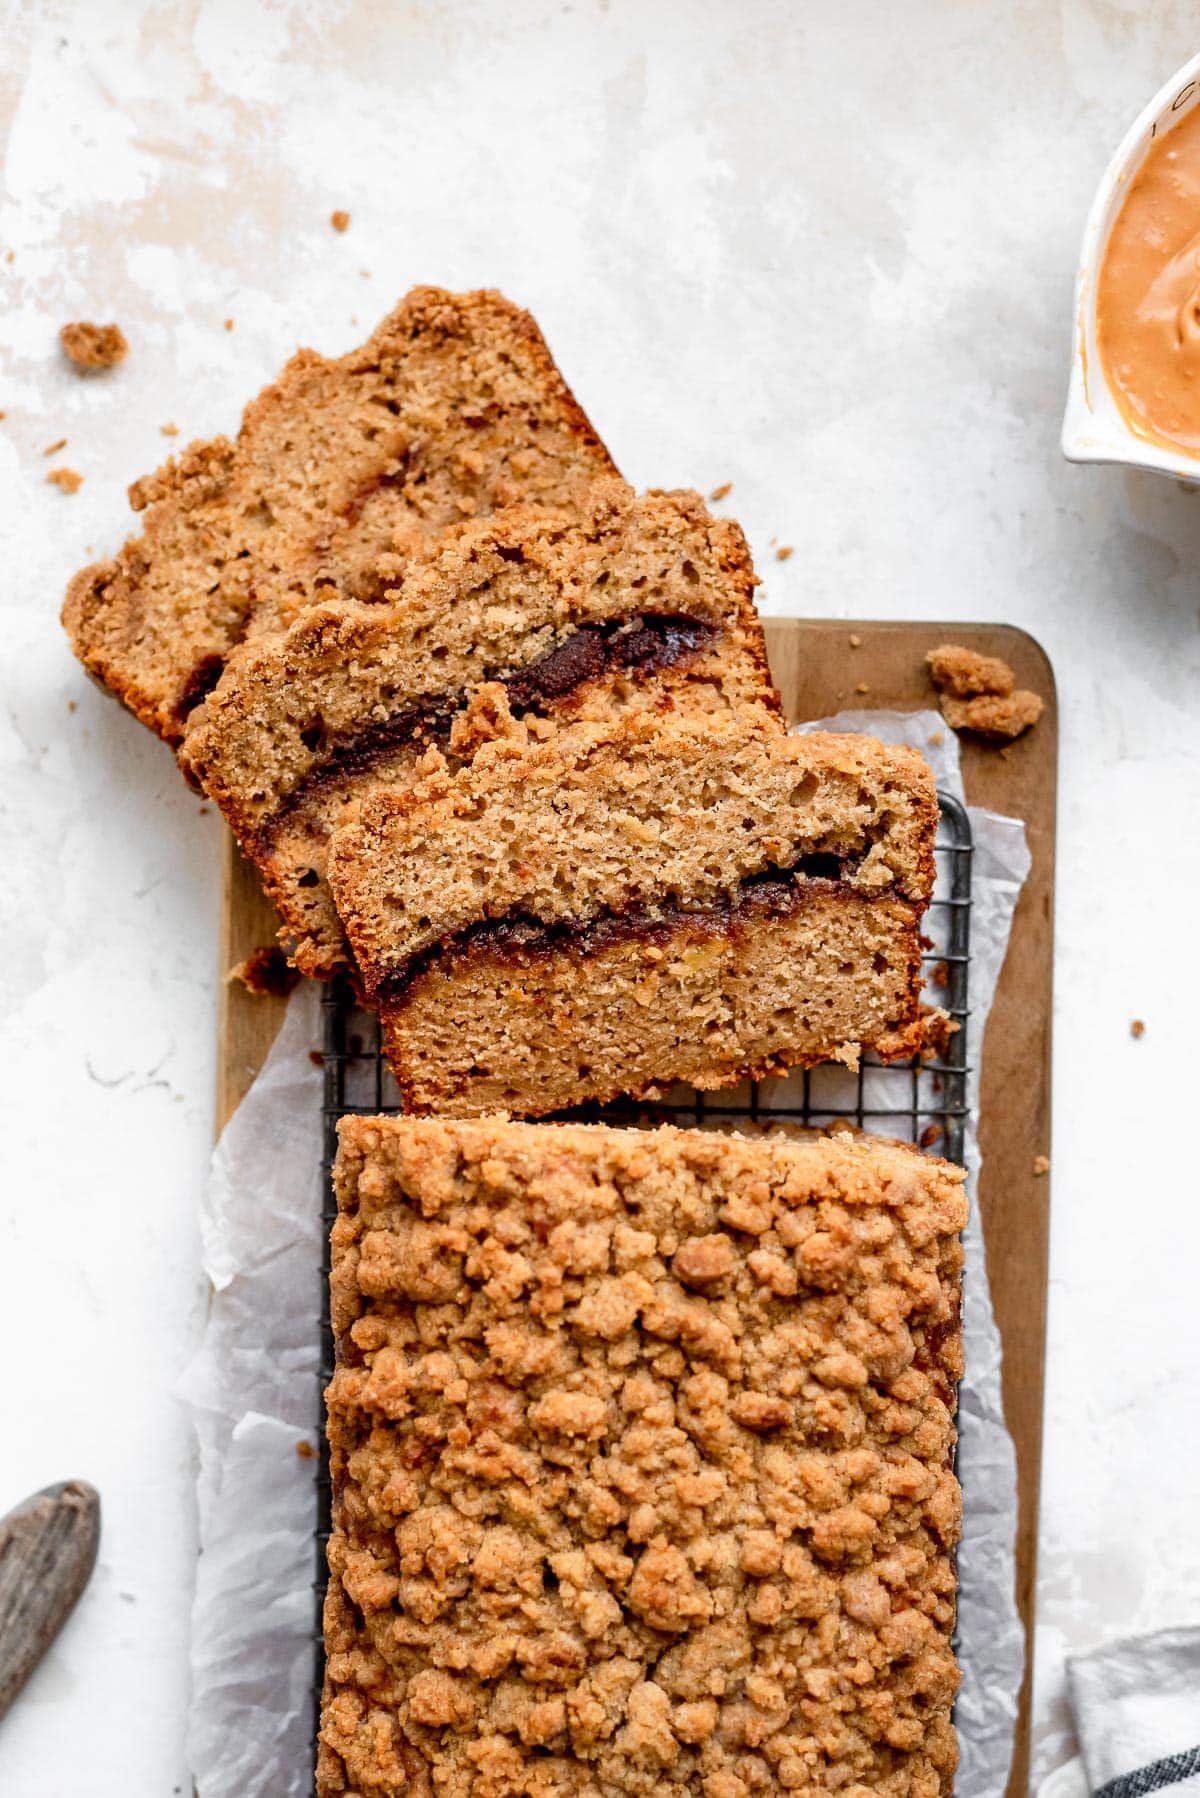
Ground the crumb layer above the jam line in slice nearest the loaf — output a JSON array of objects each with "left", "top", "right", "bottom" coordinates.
[{"left": 329, "top": 708, "right": 937, "bottom": 994}]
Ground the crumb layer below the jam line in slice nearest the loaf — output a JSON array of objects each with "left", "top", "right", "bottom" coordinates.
[{"left": 380, "top": 879, "right": 925, "bottom": 1117}]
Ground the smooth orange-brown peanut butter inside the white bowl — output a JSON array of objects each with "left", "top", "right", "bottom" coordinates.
[{"left": 1096, "top": 106, "right": 1200, "bottom": 457}]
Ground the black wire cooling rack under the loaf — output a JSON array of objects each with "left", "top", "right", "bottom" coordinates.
[{"left": 313, "top": 793, "right": 972, "bottom": 1753}]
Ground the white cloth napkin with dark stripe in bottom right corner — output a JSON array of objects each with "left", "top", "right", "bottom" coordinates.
[{"left": 1038, "top": 1629, "right": 1200, "bottom": 1798}]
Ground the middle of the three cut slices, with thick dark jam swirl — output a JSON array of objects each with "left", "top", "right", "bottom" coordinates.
[{"left": 180, "top": 480, "right": 781, "bottom": 976}]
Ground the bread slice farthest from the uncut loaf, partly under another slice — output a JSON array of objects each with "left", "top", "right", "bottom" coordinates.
[{"left": 63, "top": 288, "right": 615, "bottom": 743}]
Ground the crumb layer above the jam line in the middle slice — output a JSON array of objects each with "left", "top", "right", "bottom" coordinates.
[{"left": 180, "top": 480, "right": 781, "bottom": 841}]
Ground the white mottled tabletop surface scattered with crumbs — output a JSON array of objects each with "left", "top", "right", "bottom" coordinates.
[{"left": 0, "top": 0, "right": 1200, "bottom": 1798}]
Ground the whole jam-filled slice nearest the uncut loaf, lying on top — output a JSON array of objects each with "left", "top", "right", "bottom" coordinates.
[{"left": 329, "top": 710, "right": 937, "bottom": 1117}]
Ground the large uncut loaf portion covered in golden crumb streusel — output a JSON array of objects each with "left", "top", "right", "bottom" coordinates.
[{"left": 317, "top": 1118, "right": 966, "bottom": 1798}]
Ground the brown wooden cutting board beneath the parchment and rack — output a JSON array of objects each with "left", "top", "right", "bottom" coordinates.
[{"left": 216, "top": 619, "right": 1058, "bottom": 1798}]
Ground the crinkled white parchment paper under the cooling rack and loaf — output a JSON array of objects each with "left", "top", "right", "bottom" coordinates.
[{"left": 180, "top": 712, "right": 1029, "bottom": 1798}]
